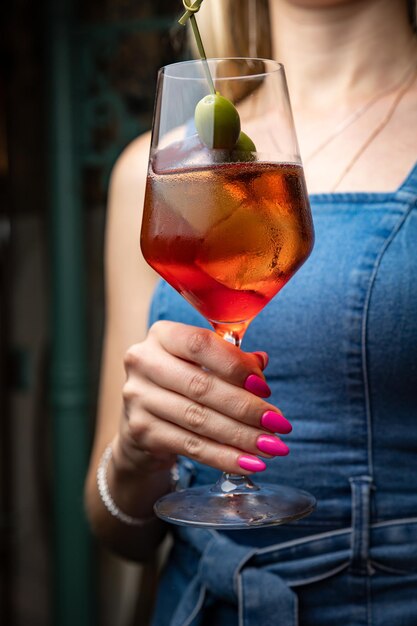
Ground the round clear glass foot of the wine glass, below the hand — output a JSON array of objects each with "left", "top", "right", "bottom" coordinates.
[{"left": 154, "top": 474, "right": 316, "bottom": 530}]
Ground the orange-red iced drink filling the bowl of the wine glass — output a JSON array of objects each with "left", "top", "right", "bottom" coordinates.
[{"left": 141, "top": 162, "right": 314, "bottom": 329}]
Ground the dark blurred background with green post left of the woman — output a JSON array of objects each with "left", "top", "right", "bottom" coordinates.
[{"left": 0, "top": 0, "right": 189, "bottom": 626}]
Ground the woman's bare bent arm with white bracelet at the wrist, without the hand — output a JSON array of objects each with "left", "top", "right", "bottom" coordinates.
[{"left": 85, "top": 135, "right": 169, "bottom": 560}]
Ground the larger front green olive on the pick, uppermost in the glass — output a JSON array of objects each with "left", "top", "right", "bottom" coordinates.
[{"left": 194, "top": 93, "right": 240, "bottom": 150}]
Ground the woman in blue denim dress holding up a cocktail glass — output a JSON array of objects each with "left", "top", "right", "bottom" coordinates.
[{"left": 86, "top": 0, "right": 417, "bottom": 626}]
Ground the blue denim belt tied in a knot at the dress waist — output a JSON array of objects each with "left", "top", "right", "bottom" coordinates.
[{"left": 167, "top": 510, "right": 417, "bottom": 626}]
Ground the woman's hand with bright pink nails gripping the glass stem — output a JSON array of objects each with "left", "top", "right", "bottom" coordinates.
[{"left": 118, "top": 321, "right": 291, "bottom": 474}]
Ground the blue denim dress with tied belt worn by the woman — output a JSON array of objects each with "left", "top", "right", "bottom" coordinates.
[{"left": 147, "top": 165, "right": 417, "bottom": 626}]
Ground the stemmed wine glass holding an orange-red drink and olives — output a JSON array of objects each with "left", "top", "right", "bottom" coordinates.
[{"left": 141, "top": 58, "right": 315, "bottom": 529}]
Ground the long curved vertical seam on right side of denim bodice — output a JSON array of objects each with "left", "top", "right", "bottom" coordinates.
[{"left": 361, "top": 205, "right": 411, "bottom": 476}]
